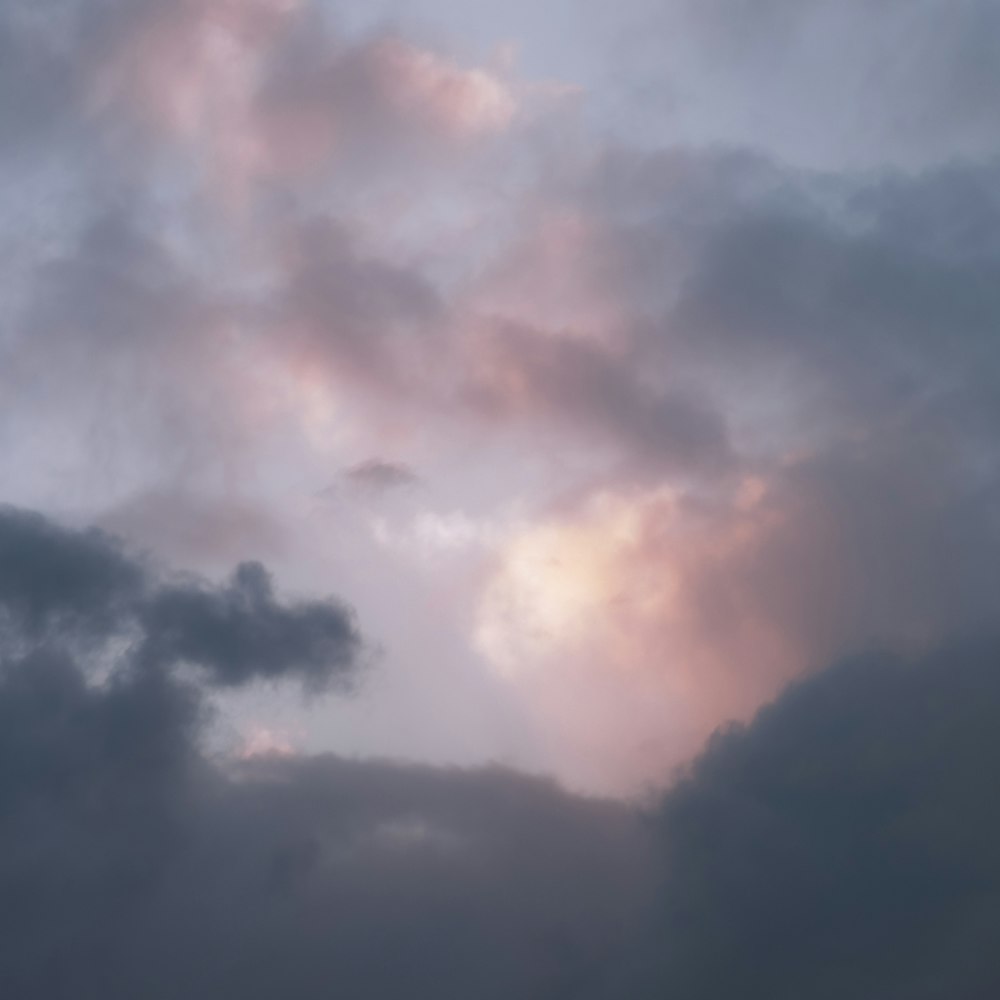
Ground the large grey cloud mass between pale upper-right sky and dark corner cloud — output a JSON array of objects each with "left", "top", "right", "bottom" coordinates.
[{"left": 591, "top": 155, "right": 1000, "bottom": 667}]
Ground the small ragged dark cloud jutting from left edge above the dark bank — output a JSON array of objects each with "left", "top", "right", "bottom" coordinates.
[{"left": 0, "top": 508, "right": 362, "bottom": 689}]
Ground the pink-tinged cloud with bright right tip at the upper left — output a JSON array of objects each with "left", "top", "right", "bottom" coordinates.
[{"left": 89, "top": 0, "right": 517, "bottom": 201}]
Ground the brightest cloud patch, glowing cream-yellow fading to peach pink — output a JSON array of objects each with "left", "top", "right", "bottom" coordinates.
[{"left": 475, "top": 481, "right": 797, "bottom": 793}]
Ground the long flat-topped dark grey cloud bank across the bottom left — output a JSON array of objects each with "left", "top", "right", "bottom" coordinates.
[{"left": 0, "top": 540, "right": 644, "bottom": 1000}]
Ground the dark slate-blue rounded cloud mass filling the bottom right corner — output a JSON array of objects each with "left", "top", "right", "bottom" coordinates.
[{"left": 632, "top": 638, "right": 1000, "bottom": 1000}]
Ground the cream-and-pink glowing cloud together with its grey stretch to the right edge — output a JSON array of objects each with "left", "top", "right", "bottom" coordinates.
[{"left": 475, "top": 374, "right": 1000, "bottom": 789}]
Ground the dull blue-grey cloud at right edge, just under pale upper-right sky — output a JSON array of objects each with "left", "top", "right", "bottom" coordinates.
[{"left": 650, "top": 159, "right": 1000, "bottom": 464}]
